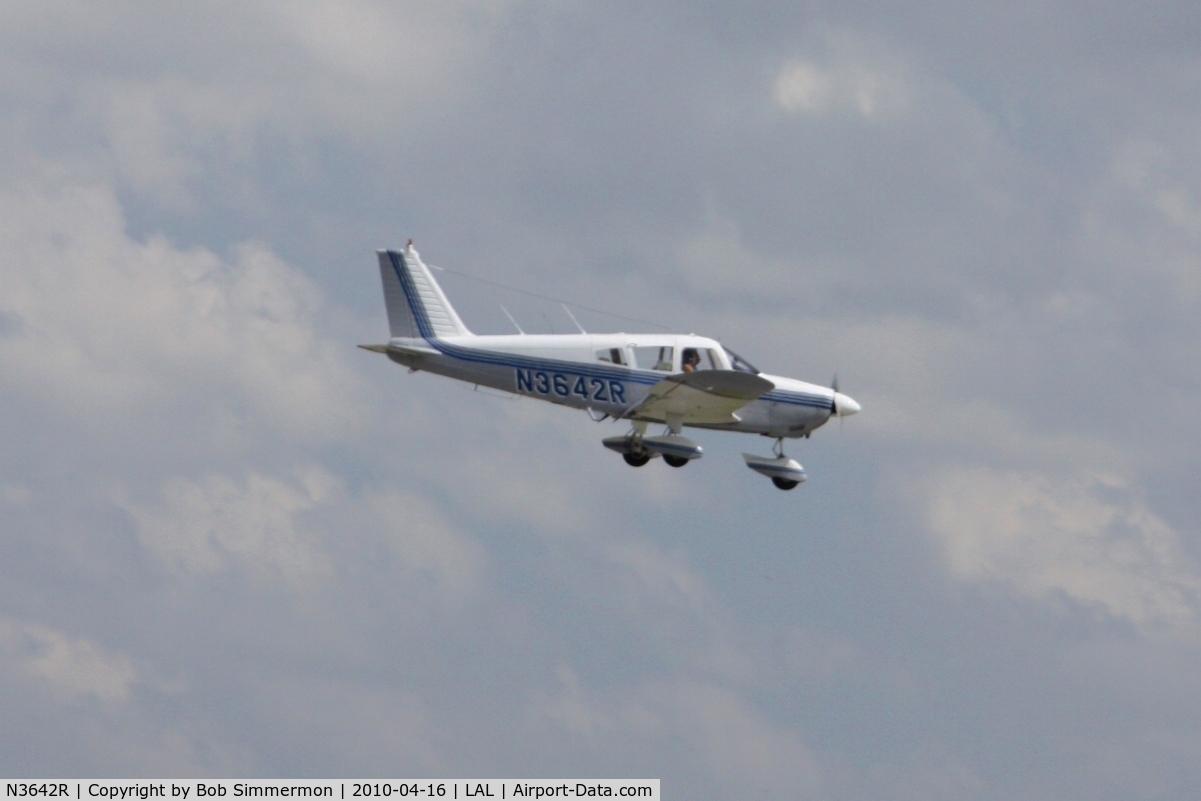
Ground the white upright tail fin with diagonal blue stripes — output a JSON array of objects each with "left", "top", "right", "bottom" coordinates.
[{"left": 376, "top": 241, "right": 471, "bottom": 339}]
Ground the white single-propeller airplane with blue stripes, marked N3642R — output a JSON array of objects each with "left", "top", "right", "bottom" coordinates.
[{"left": 359, "top": 240, "right": 860, "bottom": 490}]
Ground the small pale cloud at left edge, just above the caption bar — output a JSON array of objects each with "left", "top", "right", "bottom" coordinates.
[{"left": 0, "top": 618, "right": 137, "bottom": 701}]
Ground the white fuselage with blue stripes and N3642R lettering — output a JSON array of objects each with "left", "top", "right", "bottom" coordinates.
[{"left": 387, "top": 334, "right": 835, "bottom": 437}]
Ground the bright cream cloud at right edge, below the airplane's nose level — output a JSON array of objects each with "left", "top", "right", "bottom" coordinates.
[{"left": 928, "top": 468, "right": 1201, "bottom": 626}]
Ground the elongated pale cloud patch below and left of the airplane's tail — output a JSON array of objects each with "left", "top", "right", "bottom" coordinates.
[{"left": 118, "top": 465, "right": 486, "bottom": 602}]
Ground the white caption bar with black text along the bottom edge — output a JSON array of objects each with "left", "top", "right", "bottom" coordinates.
[{"left": 5, "top": 778, "right": 659, "bottom": 801}]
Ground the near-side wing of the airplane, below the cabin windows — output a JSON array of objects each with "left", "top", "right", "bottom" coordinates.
[{"left": 622, "top": 370, "right": 776, "bottom": 425}]
